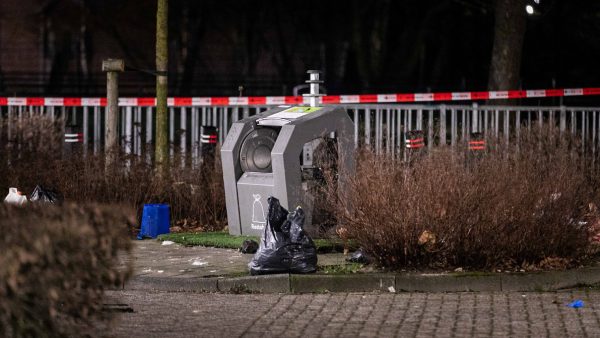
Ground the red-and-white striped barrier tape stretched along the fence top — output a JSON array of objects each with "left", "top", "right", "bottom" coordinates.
[{"left": 0, "top": 88, "right": 600, "bottom": 107}]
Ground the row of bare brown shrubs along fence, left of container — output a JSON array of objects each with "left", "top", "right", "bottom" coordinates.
[{"left": 0, "top": 116, "right": 226, "bottom": 230}]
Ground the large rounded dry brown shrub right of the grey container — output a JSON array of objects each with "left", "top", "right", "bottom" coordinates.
[{"left": 330, "top": 125, "right": 596, "bottom": 269}]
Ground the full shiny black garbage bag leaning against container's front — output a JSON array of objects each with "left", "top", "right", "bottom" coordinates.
[{"left": 248, "top": 197, "right": 317, "bottom": 275}]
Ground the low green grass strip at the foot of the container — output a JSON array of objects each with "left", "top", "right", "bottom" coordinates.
[{"left": 158, "top": 232, "right": 356, "bottom": 253}]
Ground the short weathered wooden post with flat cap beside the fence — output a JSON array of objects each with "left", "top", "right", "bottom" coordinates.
[{"left": 102, "top": 59, "right": 125, "bottom": 166}]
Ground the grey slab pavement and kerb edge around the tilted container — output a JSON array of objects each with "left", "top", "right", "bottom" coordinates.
[{"left": 124, "top": 240, "right": 600, "bottom": 293}]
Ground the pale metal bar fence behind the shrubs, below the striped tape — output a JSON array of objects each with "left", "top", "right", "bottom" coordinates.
[{"left": 0, "top": 104, "right": 600, "bottom": 164}]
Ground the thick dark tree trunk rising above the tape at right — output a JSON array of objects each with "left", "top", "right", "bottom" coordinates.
[{"left": 488, "top": 0, "right": 527, "bottom": 90}]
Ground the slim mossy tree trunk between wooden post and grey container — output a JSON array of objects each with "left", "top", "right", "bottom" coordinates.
[{"left": 155, "top": 0, "right": 169, "bottom": 174}]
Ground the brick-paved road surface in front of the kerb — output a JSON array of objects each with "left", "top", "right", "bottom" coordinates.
[{"left": 109, "top": 290, "right": 600, "bottom": 337}]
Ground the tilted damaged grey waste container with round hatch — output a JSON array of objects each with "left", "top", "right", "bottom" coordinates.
[{"left": 221, "top": 106, "right": 355, "bottom": 236}]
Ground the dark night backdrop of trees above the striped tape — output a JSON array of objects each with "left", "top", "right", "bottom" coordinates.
[{"left": 0, "top": 0, "right": 600, "bottom": 96}]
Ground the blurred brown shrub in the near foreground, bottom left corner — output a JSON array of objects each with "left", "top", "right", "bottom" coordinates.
[{"left": 0, "top": 204, "right": 133, "bottom": 337}]
